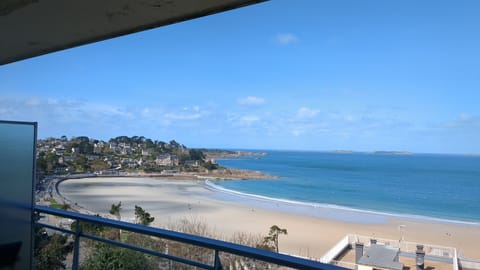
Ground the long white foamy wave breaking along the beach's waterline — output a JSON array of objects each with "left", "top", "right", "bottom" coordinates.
[{"left": 204, "top": 180, "right": 480, "bottom": 226}]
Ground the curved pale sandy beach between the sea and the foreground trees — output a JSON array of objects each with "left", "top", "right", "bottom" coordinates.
[{"left": 59, "top": 178, "right": 480, "bottom": 259}]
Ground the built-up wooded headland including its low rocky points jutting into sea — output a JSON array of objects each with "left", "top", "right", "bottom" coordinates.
[{"left": 37, "top": 136, "right": 275, "bottom": 182}]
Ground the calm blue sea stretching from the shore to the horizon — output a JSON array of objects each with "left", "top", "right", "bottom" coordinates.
[{"left": 216, "top": 151, "right": 480, "bottom": 223}]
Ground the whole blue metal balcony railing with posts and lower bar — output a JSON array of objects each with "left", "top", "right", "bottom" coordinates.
[{"left": 34, "top": 205, "right": 345, "bottom": 270}]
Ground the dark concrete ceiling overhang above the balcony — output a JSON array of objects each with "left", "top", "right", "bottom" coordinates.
[{"left": 0, "top": 0, "right": 265, "bottom": 65}]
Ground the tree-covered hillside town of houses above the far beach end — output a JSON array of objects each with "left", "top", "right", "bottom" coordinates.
[{"left": 37, "top": 136, "right": 214, "bottom": 175}]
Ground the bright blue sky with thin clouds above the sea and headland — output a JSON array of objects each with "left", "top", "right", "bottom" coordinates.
[{"left": 0, "top": 0, "right": 480, "bottom": 153}]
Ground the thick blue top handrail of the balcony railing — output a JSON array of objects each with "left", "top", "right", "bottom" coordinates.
[{"left": 34, "top": 205, "right": 345, "bottom": 270}]
